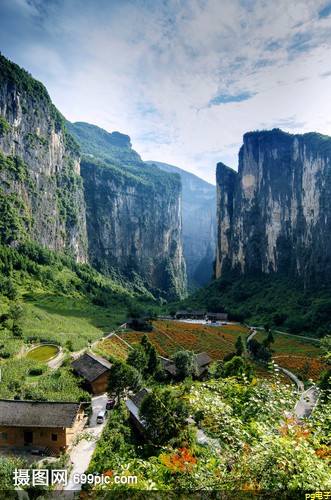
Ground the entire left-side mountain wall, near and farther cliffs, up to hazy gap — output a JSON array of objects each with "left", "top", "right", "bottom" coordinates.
[{"left": 0, "top": 55, "right": 186, "bottom": 299}]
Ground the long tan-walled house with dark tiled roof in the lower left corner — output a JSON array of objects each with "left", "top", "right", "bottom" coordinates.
[{"left": 0, "top": 399, "right": 88, "bottom": 454}]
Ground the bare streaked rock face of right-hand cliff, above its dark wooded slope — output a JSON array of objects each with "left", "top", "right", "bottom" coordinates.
[{"left": 216, "top": 129, "right": 331, "bottom": 286}]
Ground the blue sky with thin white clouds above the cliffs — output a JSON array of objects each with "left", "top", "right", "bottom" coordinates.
[{"left": 0, "top": 0, "right": 331, "bottom": 184}]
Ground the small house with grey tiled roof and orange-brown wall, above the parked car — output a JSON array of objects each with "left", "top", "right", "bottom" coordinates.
[{"left": 71, "top": 352, "right": 111, "bottom": 394}]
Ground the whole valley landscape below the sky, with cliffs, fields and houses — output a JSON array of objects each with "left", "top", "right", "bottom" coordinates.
[{"left": 0, "top": 55, "right": 331, "bottom": 498}]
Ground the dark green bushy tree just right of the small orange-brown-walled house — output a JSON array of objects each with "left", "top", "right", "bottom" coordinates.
[{"left": 107, "top": 361, "right": 142, "bottom": 401}]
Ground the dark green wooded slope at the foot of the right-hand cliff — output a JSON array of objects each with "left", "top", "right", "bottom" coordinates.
[{"left": 174, "top": 273, "right": 331, "bottom": 337}]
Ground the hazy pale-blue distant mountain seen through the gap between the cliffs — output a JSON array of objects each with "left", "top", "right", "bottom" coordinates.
[{"left": 146, "top": 161, "right": 216, "bottom": 286}]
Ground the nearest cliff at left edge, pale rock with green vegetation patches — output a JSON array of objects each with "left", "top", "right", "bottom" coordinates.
[{"left": 0, "top": 56, "right": 87, "bottom": 262}]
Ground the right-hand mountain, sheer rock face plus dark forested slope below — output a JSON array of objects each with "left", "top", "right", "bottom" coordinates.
[{"left": 172, "top": 129, "right": 331, "bottom": 337}]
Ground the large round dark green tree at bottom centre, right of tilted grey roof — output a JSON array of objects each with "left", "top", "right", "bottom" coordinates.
[{"left": 139, "top": 389, "right": 189, "bottom": 445}]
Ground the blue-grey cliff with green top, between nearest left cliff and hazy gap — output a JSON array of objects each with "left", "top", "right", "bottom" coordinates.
[{"left": 68, "top": 123, "right": 186, "bottom": 300}]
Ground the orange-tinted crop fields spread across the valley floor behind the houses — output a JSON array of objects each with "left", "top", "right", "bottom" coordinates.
[{"left": 98, "top": 320, "right": 327, "bottom": 382}]
